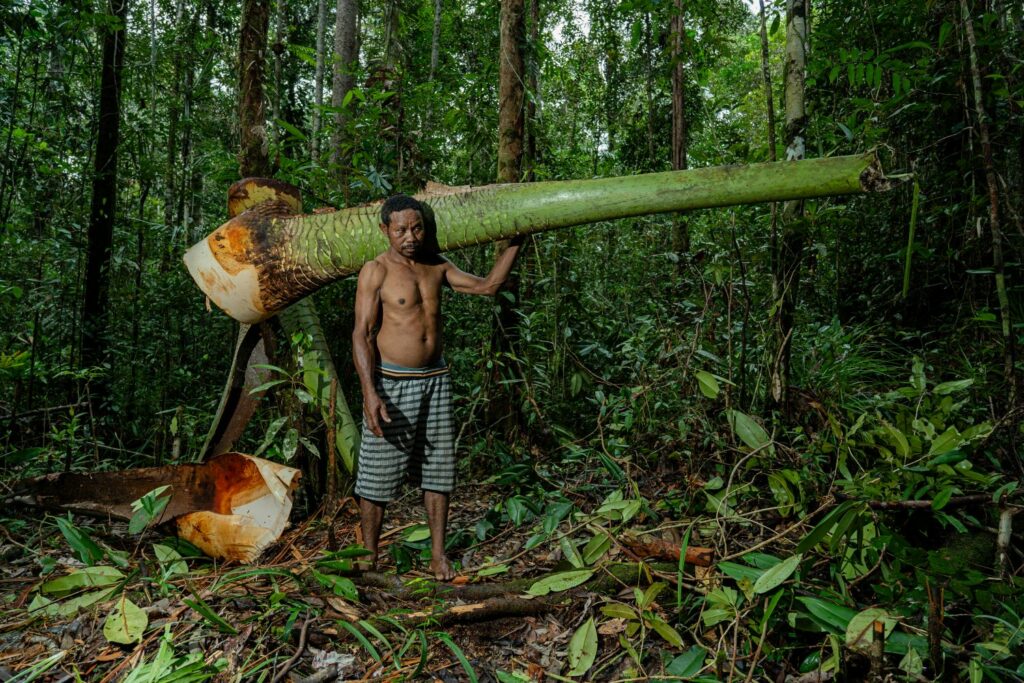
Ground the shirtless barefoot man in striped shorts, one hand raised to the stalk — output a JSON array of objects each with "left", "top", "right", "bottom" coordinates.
[{"left": 352, "top": 195, "right": 522, "bottom": 581}]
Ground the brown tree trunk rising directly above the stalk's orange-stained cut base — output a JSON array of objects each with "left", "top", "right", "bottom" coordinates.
[{"left": 239, "top": 0, "right": 272, "bottom": 178}]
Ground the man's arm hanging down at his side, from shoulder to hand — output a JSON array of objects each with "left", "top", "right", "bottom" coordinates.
[{"left": 352, "top": 261, "right": 391, "bottom": 436}]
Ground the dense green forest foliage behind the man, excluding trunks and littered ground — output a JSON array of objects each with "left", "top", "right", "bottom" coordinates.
[{"left": 0, "top": 0, "right": 1024, "bottom": 682}]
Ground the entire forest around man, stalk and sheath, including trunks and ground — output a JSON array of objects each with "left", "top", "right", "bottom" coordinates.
[{"left": 0, "top": 0, "right": 1024, "bottom": 683}]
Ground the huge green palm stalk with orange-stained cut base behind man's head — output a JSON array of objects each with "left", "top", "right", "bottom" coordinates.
[{"left": 184, "top": 153, "right": 903, "bottom": 323}]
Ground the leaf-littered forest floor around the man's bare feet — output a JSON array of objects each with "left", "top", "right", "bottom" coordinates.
[{"left": 0, "top": 464, "right": 741, "bottom": 683}]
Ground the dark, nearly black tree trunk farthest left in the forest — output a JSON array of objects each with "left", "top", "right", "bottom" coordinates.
[{"left": 82, "top": 0, "right": 127, "bottom": 385}]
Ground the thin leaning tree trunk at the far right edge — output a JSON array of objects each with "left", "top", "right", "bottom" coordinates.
[{"left": 961, "top": 0, "right": 1018, "bottom": 405}]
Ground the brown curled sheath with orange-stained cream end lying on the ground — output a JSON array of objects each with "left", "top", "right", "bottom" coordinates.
[{"left": 10, "top": 453, "right": 301, "bottom": 562}]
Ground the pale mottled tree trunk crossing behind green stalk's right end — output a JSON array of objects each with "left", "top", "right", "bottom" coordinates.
[{"left": 770, "top": 0, "right": 810, "bottom": 412}]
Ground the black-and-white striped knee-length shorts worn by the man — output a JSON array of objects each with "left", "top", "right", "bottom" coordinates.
[{"left": 355, "top": 360, "right": 456, "bottom": 503}]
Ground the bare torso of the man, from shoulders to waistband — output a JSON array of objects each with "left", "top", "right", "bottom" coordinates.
[{"left": 375, "top": 252, "right": 449, "bottom": 368}]
